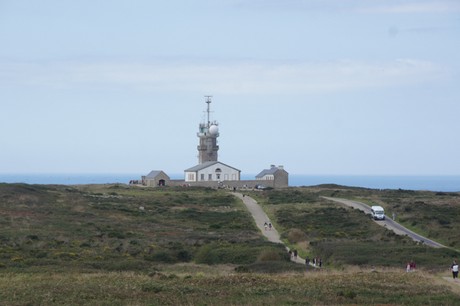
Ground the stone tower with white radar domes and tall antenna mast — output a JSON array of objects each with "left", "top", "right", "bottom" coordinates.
[{"left": 197, "top": 96, "right": 219, "bottom": 164}]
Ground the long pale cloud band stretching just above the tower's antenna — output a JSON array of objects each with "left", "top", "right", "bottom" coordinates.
[{"left": 0, "top": 59, "right": 448, "bottom": 94}]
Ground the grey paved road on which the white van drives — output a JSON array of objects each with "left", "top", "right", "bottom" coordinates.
[{"left": 322, "top": 197, "right": 446, "bottom": 248}]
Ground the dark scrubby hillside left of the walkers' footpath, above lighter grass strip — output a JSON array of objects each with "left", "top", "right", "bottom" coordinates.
[{"left": 0, "top": 184, "right": 287, "bottom": 271}]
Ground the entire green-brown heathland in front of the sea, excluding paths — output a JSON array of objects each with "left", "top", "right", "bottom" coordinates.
[{"left": 0, "top": 184, "right": 460, "bottom": 305}]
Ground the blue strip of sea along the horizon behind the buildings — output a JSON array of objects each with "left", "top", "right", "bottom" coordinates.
[{"left": 0, "top": 174, "right": 460, "bottom": 192}]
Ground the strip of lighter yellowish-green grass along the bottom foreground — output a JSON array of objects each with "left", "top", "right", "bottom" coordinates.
[{"left": 0, "top": 271, "right": 460, "bottom": 305}]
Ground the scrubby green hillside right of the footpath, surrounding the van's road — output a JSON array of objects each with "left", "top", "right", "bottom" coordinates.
[{"left": 252, "top": 186, "right": 460, "bottom": 270}]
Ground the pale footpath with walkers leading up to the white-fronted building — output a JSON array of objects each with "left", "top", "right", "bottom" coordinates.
[{"left": 232, "top": 192, "right": 305, "bottom": 265}]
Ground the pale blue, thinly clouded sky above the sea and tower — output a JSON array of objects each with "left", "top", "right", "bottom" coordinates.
[{"left": 0, "top": 0, "right": 460, "bottom": 175}]
